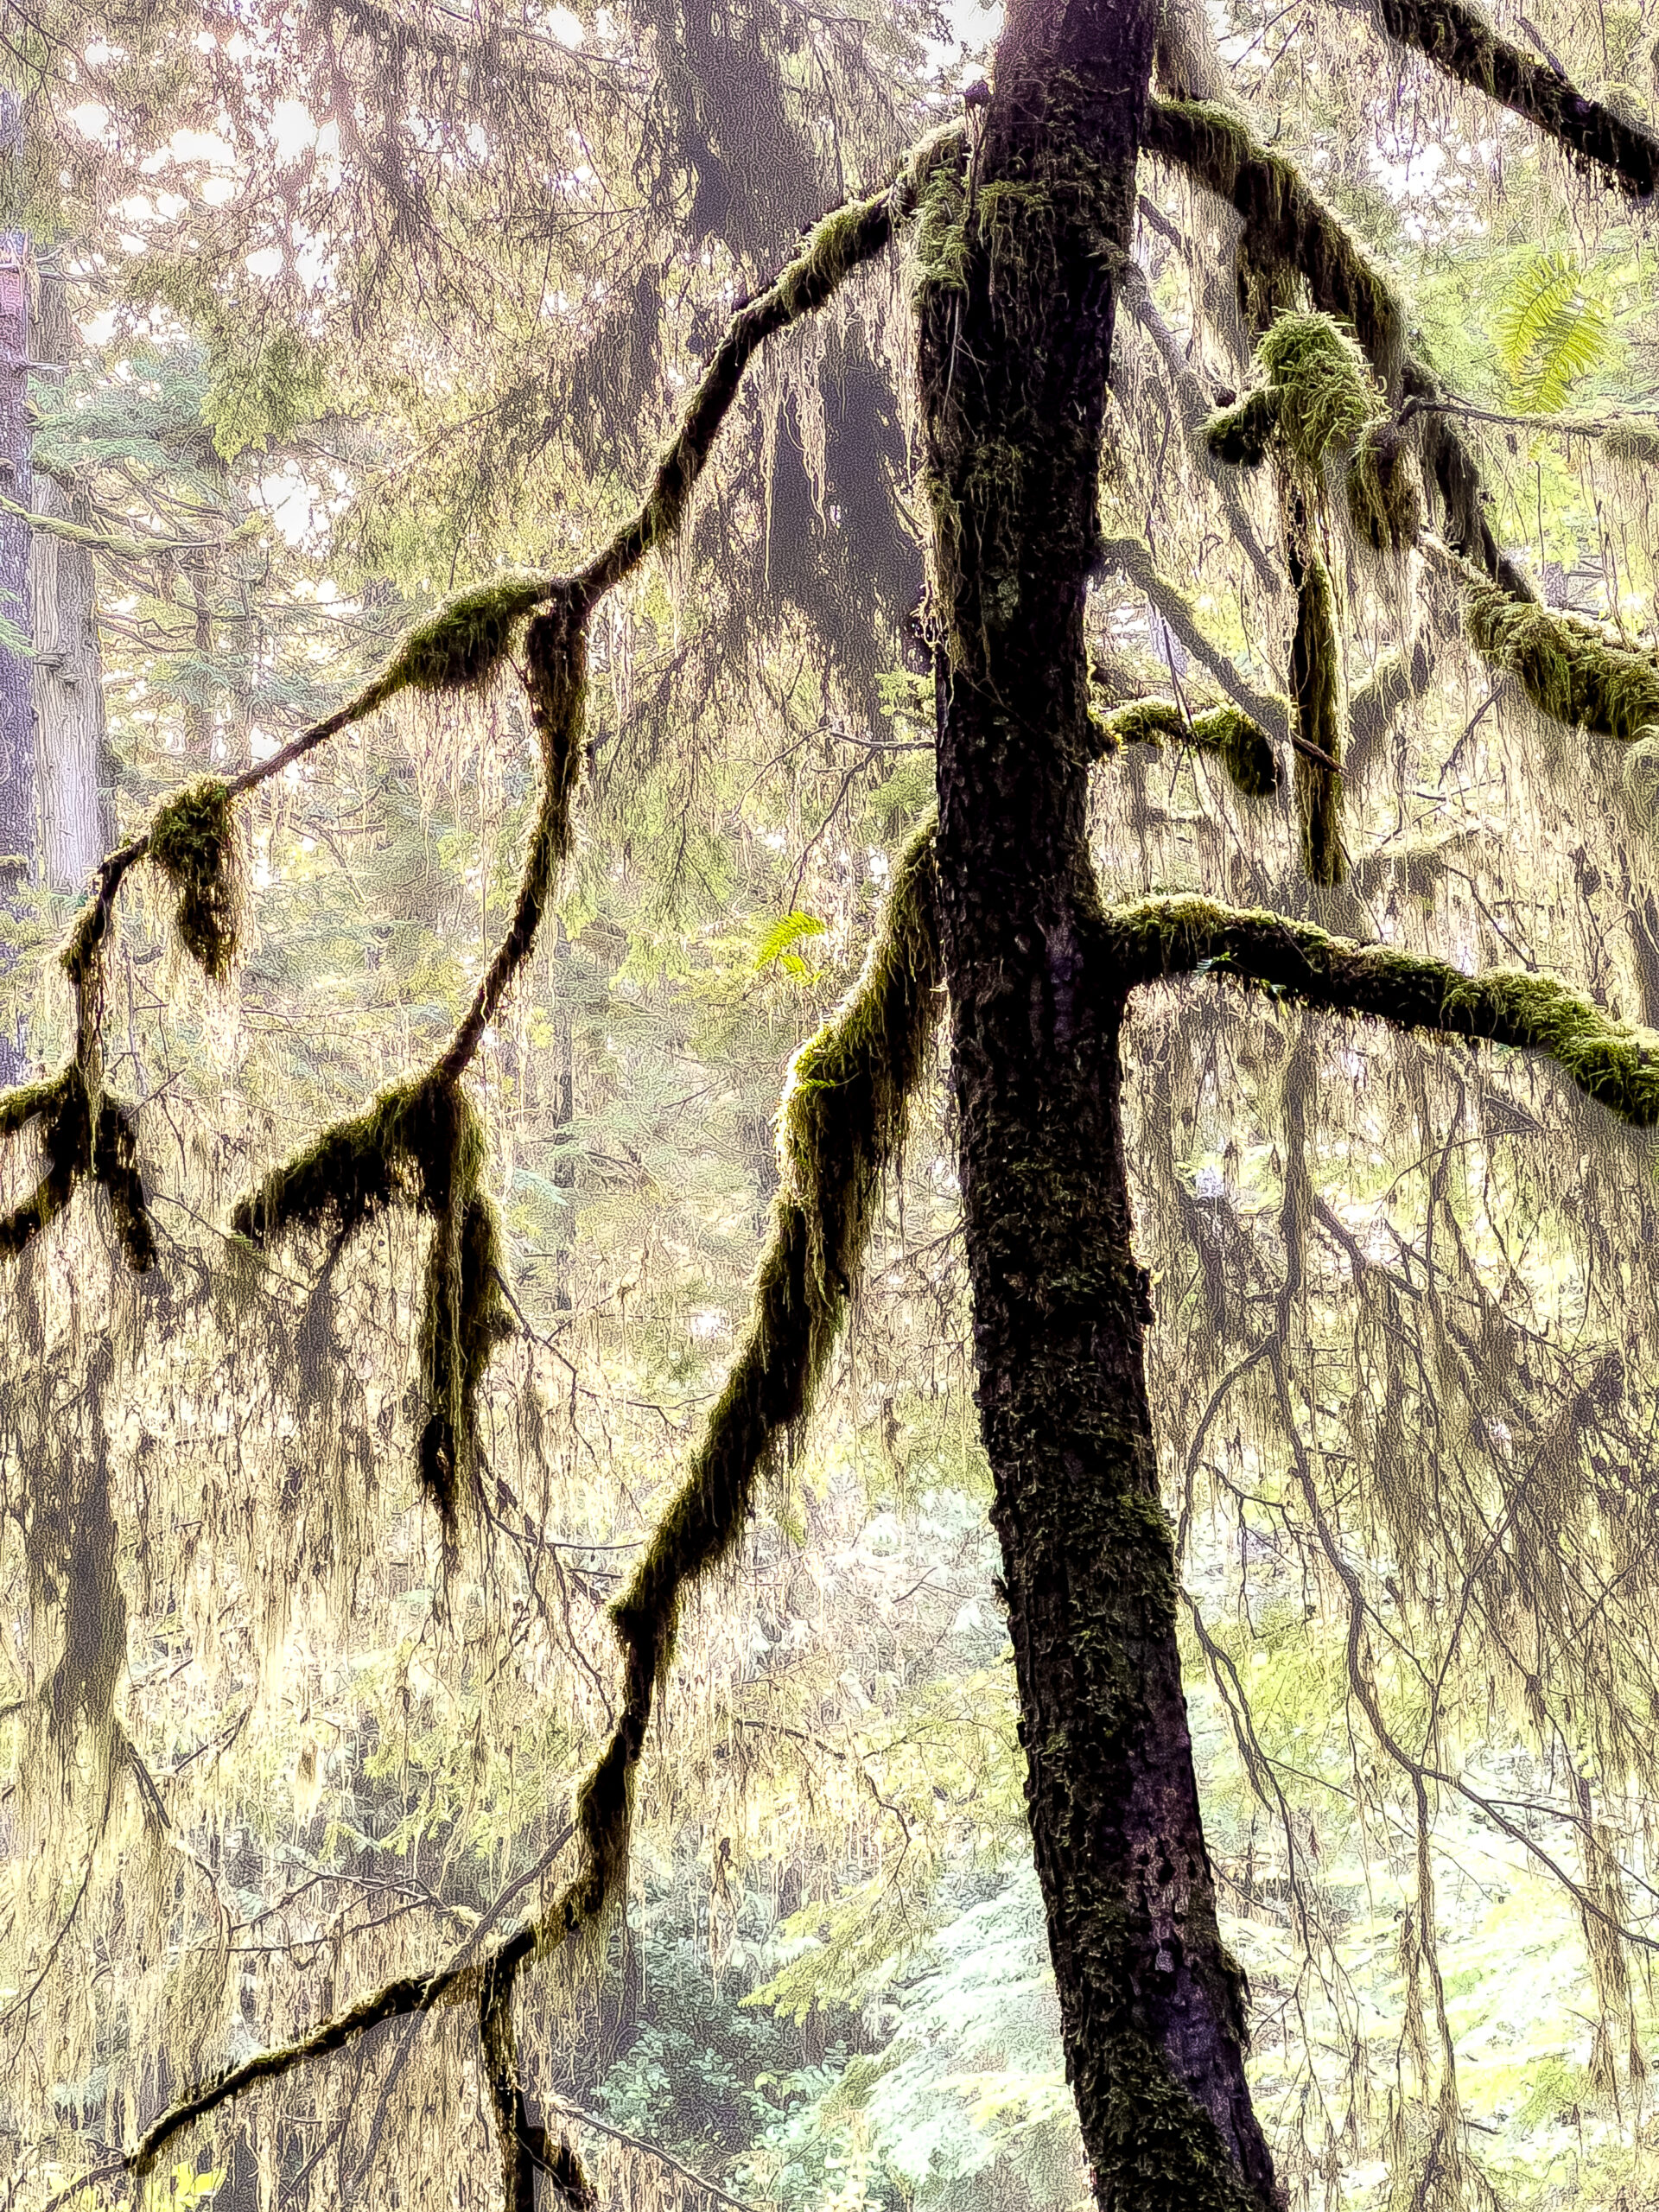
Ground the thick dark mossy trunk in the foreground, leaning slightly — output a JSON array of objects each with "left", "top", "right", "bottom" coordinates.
[{"left": 918, "top": 0, "right": 1276, "bottom": 2212}]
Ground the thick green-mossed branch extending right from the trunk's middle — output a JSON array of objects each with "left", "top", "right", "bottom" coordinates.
[{"left": 1103, "top": 898, "right": 1659, "bottom": 1128}]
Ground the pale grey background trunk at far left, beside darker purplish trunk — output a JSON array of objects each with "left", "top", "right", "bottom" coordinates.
[{"left": 29, "top": 270, "right": 113, "bottom": 892}]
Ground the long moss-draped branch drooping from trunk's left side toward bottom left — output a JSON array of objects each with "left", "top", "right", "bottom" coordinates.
[{"left": 126, "top": 821, "right": 938, "bottom": 2177}]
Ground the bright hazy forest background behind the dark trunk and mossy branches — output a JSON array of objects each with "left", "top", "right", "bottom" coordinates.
[{"left": 0, "top": 0, "right": 1659, "bottom": 2212}]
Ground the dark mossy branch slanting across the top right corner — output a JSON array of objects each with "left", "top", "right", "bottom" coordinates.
[{"left": 1374, "top": 0, "right": 1659, "bottom": 199}]
